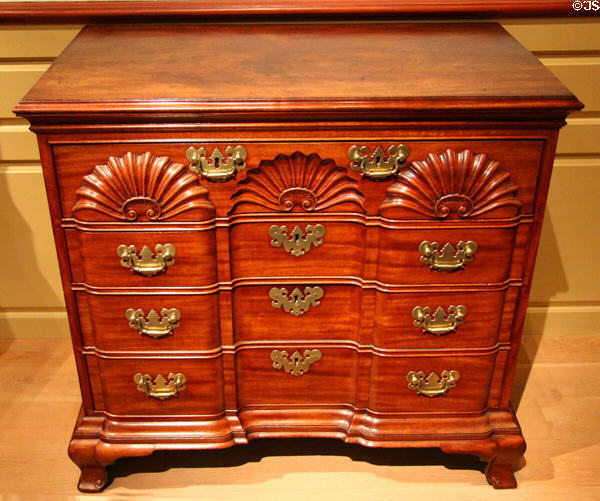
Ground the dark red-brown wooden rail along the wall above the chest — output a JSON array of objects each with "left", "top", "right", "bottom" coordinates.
[{"left": 0, "top": 0, "right": 573, "bottom": 24}]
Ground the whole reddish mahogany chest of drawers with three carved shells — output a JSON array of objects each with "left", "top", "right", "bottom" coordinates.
[{"left": 16, "top": 24, "right": 581, "bottom": 491}]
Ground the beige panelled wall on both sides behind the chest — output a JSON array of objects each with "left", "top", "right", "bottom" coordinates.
[{"left": 0, "top": 19, "right": 600, "bottom": 338}]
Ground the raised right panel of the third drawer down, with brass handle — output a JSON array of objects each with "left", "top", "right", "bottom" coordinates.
[{"left": 373, "top": 291, "right": 514, "bottom": 349}]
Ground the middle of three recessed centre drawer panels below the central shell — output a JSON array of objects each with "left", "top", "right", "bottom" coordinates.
[{"left": 233, "top": 284, "right": 362, "bottom": 342}]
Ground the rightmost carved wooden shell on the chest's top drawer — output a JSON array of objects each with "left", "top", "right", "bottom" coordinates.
[{"left": 380, "top": 150, "right": 521, "bottom": 219}]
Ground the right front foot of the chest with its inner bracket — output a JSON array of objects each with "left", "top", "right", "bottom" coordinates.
[{"left": 440, "top": 435, "right": 525, "bottom": 489}]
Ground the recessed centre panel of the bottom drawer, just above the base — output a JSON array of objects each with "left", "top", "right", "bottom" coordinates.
[{"left": 235, "top": 344, "right": 358, "bottom": 407}]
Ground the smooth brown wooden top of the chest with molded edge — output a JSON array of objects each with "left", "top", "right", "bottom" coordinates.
[{"left": 16, "top": 23, "right": 580, "bottom": 121}]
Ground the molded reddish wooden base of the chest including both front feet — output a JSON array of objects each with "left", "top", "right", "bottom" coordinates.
[{"left": 69, "top": 407, "right": 525, "bottom": 492}]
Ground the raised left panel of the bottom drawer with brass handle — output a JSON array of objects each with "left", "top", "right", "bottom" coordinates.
[{"left": 98, "top": 357, "right": 225, "bottom": 416}]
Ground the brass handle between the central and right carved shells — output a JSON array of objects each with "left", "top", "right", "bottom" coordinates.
[{"left": 348, "top": 144, "right": 410, "bottom": 181}]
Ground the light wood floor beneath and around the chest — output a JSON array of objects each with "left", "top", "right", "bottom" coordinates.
[{"left": 0, "top": 335, "right": 600, "bottom": 501}]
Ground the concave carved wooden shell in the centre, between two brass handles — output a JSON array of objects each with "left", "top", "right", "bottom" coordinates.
[{"left": 231, "top": 151, "right": 364, "bottom": 212}]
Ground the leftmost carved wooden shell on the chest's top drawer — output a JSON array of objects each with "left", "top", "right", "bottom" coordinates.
[{"left": 73, "top": 153, "right": 214, "bottom": 221}]
